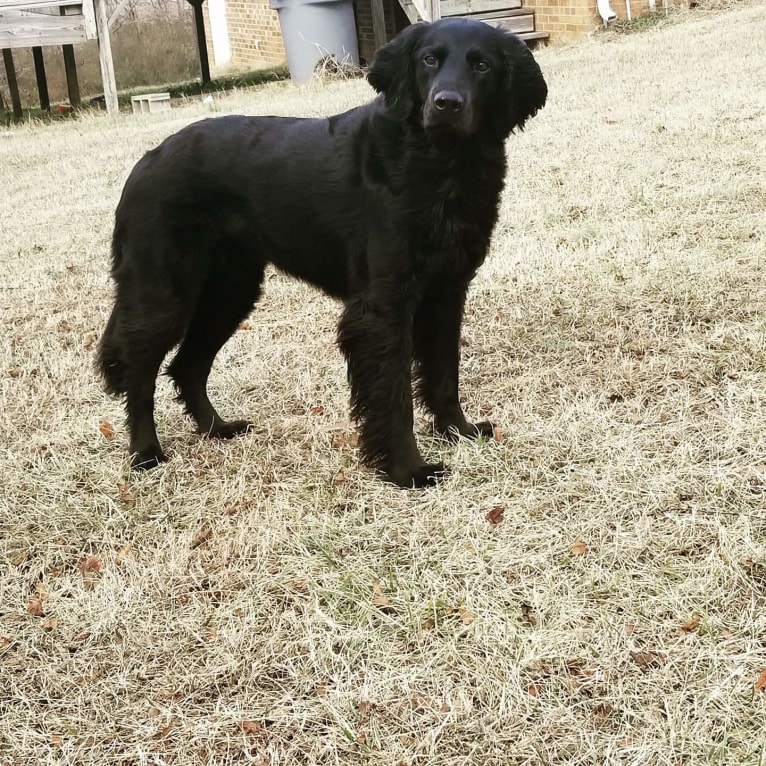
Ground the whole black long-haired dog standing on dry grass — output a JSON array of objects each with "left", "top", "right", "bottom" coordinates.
[{"left": 99, "top": 19, "right": 547, "bottom": 487}]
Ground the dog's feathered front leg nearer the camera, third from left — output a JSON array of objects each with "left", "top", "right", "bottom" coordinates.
[{"left": 338, "top": 282, "right": 445, "bottom": 487}]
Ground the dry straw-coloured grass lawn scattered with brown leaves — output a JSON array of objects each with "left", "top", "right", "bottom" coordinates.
[{"left": 0, "top": 7, "right": 766, "bottom": 766}]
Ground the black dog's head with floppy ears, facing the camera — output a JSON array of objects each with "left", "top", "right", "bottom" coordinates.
[{"left": 367, "top": 19, "right": 548, "bottom": 137}]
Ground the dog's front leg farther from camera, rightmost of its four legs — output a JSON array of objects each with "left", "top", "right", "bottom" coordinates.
[{"left": 413, "top": 283, "right": 493, "bottom": 440}]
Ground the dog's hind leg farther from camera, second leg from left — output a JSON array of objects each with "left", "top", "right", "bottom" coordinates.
[{"left": 168, "top": 253, "right": 265, "bottom": 439}]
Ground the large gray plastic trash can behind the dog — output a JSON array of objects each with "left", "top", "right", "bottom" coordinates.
[{"left": 270, "top": 0, "right": 359, "bottom": 83}]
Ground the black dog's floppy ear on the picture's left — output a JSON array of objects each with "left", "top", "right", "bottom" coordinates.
[{"left": 367, "top": 22, "right": 427, "bottom": 119}]
